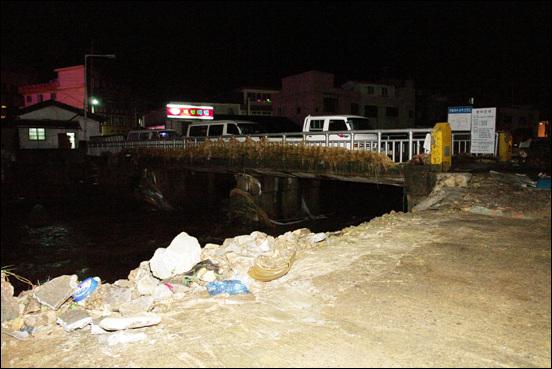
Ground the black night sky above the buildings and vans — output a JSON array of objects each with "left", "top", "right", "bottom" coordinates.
[{"left": 1, "top": 1, "right": 552, "bottom": 113}]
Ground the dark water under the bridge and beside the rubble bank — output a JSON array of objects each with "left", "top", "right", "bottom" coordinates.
[{"left": 1, "top": 181, "right": 403, "bottom": 294}]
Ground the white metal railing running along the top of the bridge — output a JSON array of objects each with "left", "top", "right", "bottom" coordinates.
[{"left": 88, "top": 128, "right": 478, "bottom": 162}]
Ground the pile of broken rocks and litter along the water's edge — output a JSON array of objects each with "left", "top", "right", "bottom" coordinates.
[{"left": 2, "top": 228, "right": 326, "bottom": 345}]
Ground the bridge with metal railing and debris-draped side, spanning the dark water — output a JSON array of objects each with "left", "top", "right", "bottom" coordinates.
[{"left": 88, "top": 129, "right": 484, "bottom": 216}]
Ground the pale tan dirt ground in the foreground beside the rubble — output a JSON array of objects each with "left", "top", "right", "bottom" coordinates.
[{"left": 1, "top": 174, "right": 551, "bottom": 368}]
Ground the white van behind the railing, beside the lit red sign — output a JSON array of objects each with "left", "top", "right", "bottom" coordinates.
[{"left": 186, "top": 120, "right": 266, "bottom": 141}]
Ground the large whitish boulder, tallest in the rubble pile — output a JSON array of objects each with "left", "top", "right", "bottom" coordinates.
[{"left": 150, "top": 232, "right": 201, "bottom": 279}]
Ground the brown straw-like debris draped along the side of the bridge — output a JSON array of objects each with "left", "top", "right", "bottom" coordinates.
[{"left": 113, "top": 138, "right": 397, "bottom": 176}]
